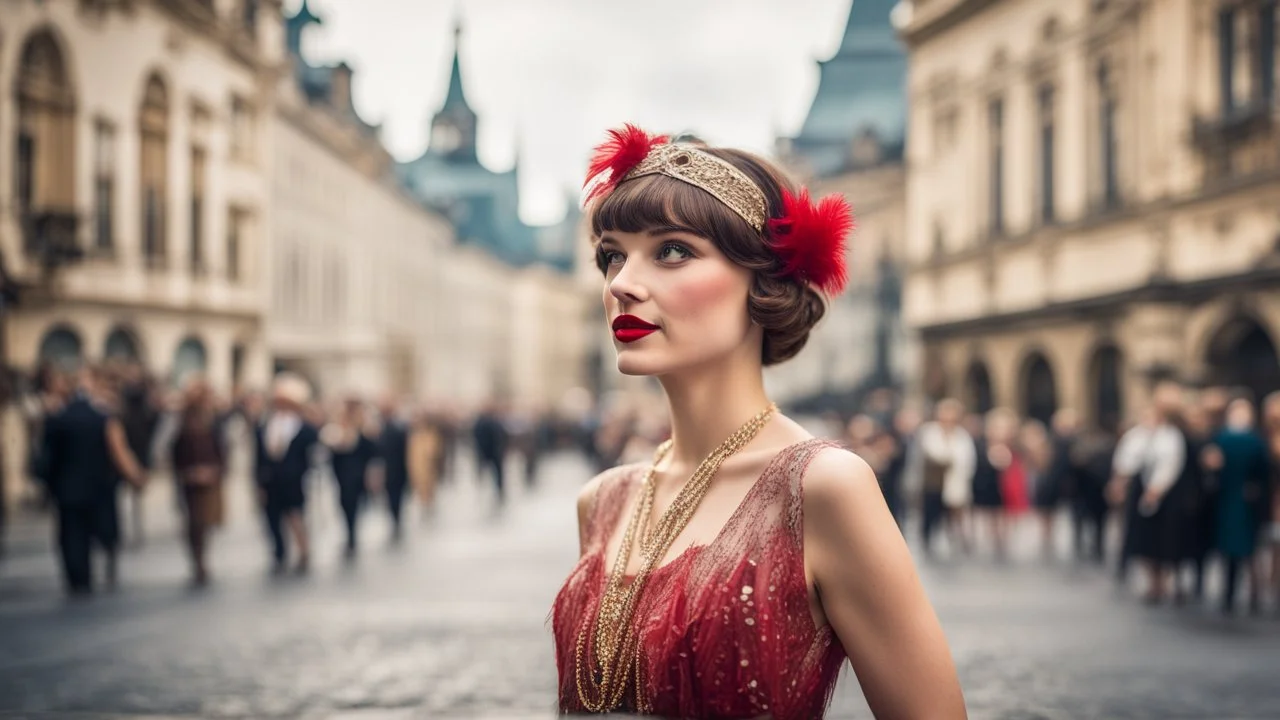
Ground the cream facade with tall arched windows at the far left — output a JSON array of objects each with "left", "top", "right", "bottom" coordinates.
[{"left": 0, "top": 0, "right": 280, "bottom": 389}]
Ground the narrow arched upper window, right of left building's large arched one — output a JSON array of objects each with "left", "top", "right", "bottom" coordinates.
[{"left": 140, "top": 76, "right": 169, "bottom": 268}]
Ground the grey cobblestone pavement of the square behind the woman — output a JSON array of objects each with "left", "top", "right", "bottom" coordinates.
[{"left": 0, "top": 456, "right": 1280, "bottom": 720}]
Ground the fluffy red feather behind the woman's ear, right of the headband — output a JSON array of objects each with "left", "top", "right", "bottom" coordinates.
[{"left": 769, "top": 188, "right": 854, "bottom": 295}]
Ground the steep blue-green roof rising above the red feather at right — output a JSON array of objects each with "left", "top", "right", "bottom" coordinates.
[{"left": 792, "top": 0, "right": 906, "bottom": 176}]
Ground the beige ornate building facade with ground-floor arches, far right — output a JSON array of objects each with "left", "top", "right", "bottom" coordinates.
[{"left": 899, "top": 0, "right": 1280, "bottom": 425}]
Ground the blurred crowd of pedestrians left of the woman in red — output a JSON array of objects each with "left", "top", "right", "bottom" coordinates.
[{"left": 23, "top": 364, "right": 582, "bottom": 596}]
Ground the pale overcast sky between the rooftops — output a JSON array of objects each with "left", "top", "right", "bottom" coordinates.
[{"left": 284, "top": 0, "right": 850, "bottom": 223}]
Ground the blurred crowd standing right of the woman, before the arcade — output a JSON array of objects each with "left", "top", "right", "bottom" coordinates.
[{"left": 840, "top": 380, "right": 1280, "bottom": 614}]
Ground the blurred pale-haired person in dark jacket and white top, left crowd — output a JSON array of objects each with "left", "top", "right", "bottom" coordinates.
[{"left": 255, "top": 373, "right": 320, "bottom": 574}]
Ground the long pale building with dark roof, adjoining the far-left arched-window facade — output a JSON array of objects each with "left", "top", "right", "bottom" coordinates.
[{"left": 268, "top": 3, "right": 453, "bottom": 397}]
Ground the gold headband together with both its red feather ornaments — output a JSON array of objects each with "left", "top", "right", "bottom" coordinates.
[{"left": 584, "top": 124, "right": 854, "bottom": 295}]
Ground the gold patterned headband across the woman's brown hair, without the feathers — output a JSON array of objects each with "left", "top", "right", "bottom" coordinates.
[{"left": 622, "top": 142, "right": 769, "bottom": 232}]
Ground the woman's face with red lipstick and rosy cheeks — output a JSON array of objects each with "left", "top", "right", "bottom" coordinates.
[{"left": 598, "top": 232, "right": 763, "bottom": 375}]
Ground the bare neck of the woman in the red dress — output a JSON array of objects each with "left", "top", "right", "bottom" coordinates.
[{"left": 662, "top": 348, "right": 769, "bottom": 470}]
